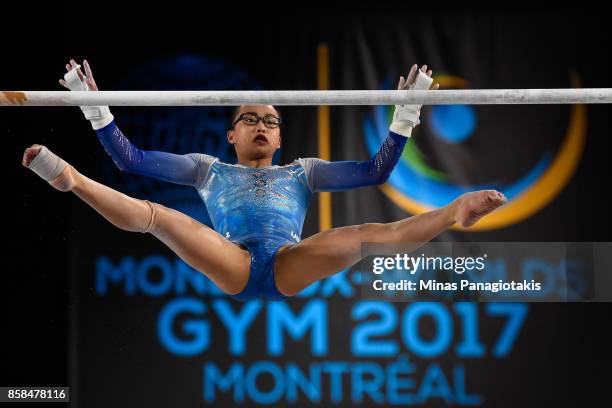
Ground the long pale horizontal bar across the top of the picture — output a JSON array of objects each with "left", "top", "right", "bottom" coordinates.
[{"left": 0, "top": 88, "right": 612, "bottom": 106}]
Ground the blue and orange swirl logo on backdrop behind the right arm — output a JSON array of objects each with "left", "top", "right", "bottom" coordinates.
[{"left": 363, "top": 75, "right": 586, "bottom": 231}]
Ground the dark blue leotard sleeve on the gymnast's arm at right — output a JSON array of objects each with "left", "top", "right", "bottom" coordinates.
[{"left": 299, "top": 132, "right": 407, "bottom": 192}]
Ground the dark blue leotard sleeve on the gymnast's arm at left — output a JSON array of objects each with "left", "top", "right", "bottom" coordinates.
[{"left": 96, "top": 121, "right": 214, "bottom": 186}]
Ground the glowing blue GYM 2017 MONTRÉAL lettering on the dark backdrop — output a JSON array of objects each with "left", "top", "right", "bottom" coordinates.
[{"left": 92, "top": 255, "right": 529, "bottom": 406}]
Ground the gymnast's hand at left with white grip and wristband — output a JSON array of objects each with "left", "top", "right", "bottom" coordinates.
[{"left": 59, "top": 59, "right": 114, "bottom": 130}]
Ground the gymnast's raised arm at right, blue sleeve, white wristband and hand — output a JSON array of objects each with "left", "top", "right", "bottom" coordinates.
[{"left": 299, "top": 65, "right": 439, "bottom": 192}]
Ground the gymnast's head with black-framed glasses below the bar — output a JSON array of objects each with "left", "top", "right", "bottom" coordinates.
[{"left": 227, "top": 105, "right": 281, "bottom": 160}]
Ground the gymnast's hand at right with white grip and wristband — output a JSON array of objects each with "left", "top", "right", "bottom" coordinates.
[{"left": 389, "top": 64, "right": 440, "bottom": 137}]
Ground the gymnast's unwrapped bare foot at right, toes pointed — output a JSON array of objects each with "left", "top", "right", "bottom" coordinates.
[{"left": 451, "top": 190, "right": 508, "bottom": 228}]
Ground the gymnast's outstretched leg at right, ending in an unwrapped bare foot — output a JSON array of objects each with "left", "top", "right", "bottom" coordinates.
[{"left": 274, "top": 190, "right": 506, "bottom": 296}]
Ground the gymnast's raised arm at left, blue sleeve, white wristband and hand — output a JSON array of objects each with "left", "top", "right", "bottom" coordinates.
[{"left": 60, "top": 59, "right": 201, "bottom": 186}]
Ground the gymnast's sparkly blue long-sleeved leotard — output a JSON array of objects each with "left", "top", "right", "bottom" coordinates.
[{"left": 96, "top": 122, "right": 407, "bottom": 301}]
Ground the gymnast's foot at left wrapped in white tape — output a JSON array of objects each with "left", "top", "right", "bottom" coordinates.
[{"left": 21, "top": 144, "right": 75, "bottom": 191}]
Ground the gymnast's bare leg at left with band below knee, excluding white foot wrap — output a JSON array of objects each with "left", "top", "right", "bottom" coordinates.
[{"left": 22, "top": 145, "right": 251, "bottom": 295}]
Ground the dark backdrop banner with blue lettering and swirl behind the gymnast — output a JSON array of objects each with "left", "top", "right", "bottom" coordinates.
[{"left": 5, "top": 6, "right": 612, "bottom": 406}]
